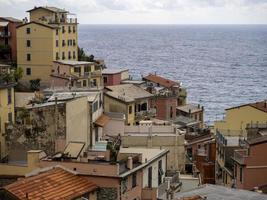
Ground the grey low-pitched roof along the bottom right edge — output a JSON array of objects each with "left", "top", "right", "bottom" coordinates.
[{"left": 174, "top": 184, "right": 267, "bottom": 200}]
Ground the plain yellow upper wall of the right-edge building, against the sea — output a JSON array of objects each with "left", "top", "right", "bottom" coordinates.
[{"left": 214, "top": 101, "right": 267, "bottom": 136}]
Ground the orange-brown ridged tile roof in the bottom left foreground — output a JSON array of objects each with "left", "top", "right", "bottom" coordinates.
[{"left": 4, "top": 167, "right": 97, "bottom": 200}]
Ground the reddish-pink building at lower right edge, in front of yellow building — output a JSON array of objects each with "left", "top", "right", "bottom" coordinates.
[{"left": 233, "top": 136, "right": 267, "bottom": 190}]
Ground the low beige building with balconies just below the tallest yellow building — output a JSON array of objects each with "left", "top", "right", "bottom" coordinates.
[{"left": 51, "top": 60, "right": 103, "bottom": 88}]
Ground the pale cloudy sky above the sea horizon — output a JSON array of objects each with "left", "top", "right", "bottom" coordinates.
[{"left": 0, "top": 0, "right": 267, "bottom": 24}]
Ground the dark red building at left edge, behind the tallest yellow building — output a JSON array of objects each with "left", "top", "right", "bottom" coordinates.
[{"left": 0, "top": 17, "right": 22, "bottom": 62}]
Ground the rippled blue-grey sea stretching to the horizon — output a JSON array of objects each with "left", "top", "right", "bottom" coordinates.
[{"left": 79, "top": 25, "right": 267, "bottom": 123}]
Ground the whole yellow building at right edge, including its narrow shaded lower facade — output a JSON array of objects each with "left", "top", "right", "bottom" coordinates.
[{"left": 214, "top": 101, "right": 267, "bottom": 187}]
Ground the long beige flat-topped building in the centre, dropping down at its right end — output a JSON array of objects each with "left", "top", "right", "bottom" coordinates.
[{"left": 121, "top": 125, "right": 185, "bottom": 172}]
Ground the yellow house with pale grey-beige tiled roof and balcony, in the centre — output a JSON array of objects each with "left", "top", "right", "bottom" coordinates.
[{"left": 104, "top": 84, "right": 156, "bottom": 125}]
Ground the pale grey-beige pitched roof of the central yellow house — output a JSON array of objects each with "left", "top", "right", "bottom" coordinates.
[{"left": 106, "top": 84, "right": 153, "bottom": 102}]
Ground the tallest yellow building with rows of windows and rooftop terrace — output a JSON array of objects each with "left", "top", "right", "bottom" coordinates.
[{"left": 17, "top": 7, "right": 78, "bottom": 85}]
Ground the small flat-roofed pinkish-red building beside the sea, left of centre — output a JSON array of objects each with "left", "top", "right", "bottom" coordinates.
[{"left": 102, "top": 69, "right": 129, "bottom": 86}]
